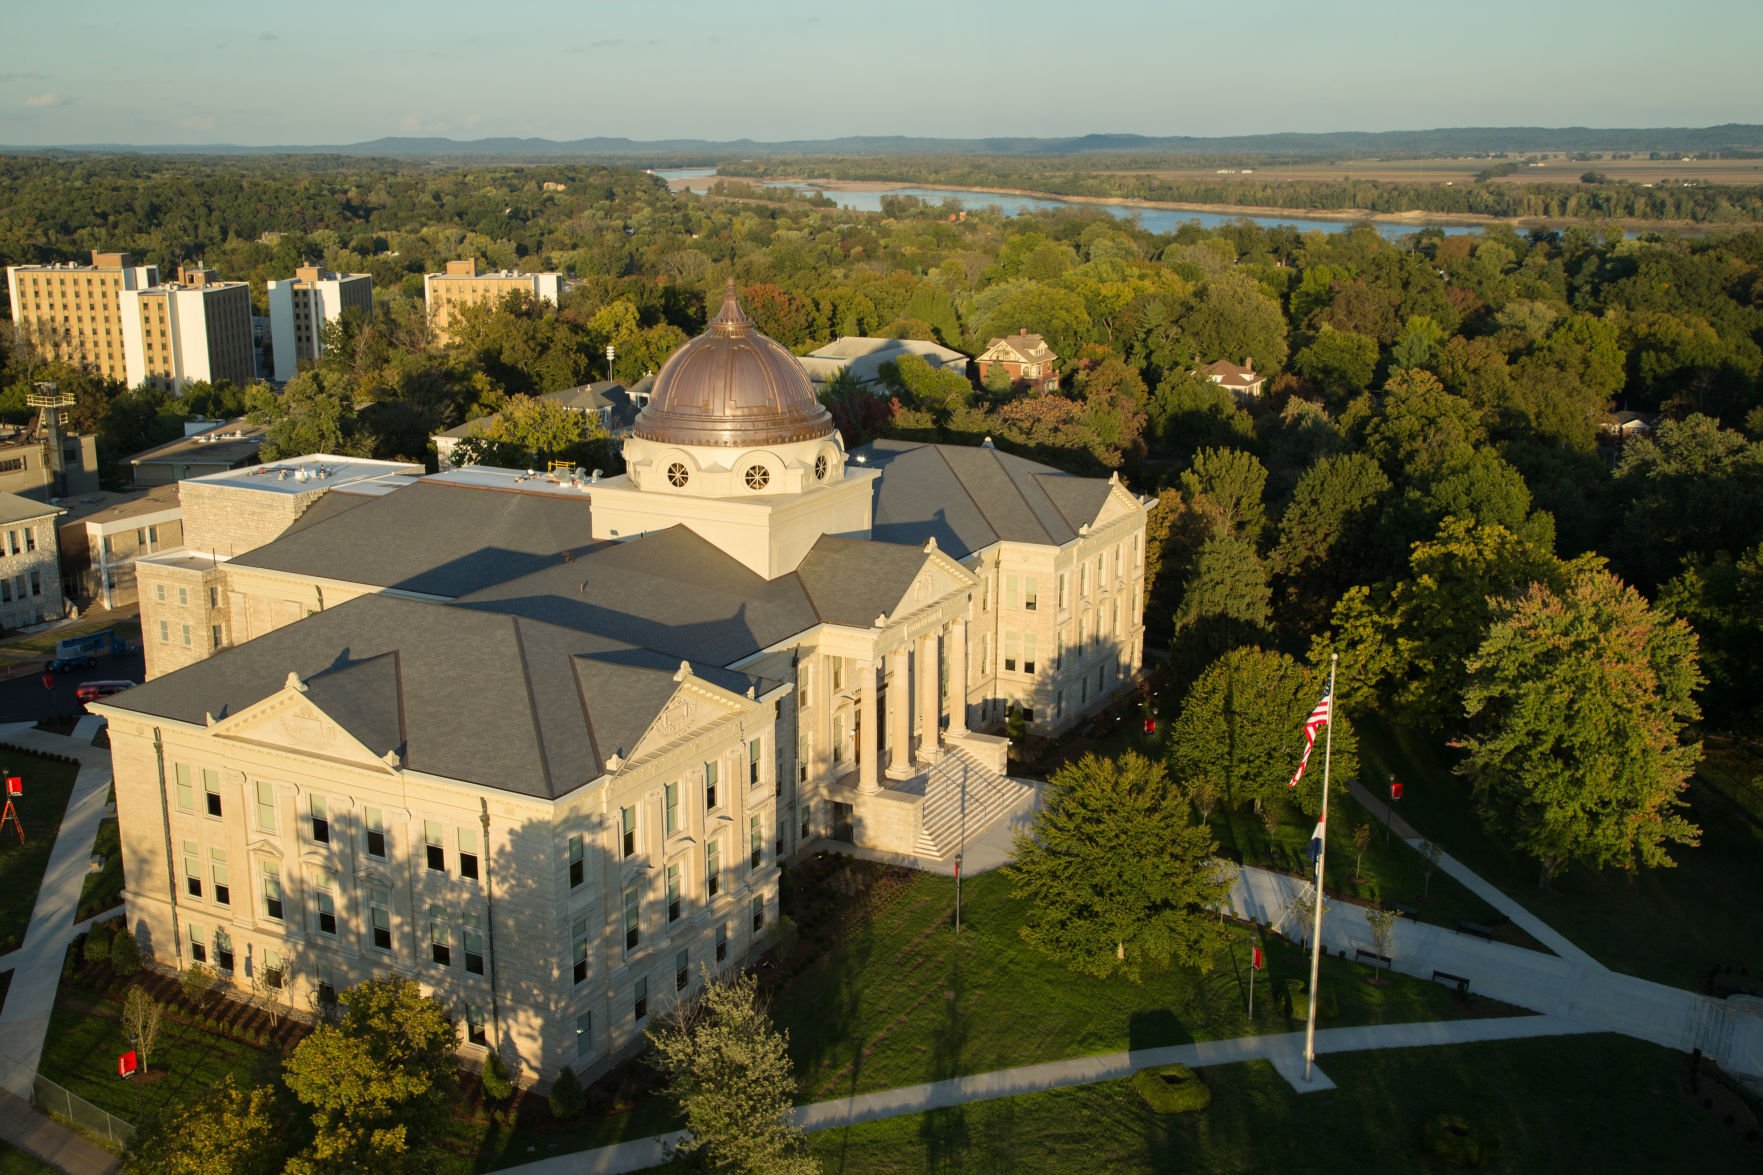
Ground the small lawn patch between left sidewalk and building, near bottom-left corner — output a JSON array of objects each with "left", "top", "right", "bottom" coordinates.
[{"left": 39, "top": 986, "right": 279, "bottom": 1126}]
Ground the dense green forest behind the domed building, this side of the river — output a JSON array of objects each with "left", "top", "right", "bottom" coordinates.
[{"left": 10, "top": 159, "right": 1763, "bottom": 758}]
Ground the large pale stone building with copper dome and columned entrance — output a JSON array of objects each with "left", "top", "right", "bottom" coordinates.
[{"left": 106, "top": 285, "right": 1149, "bottom": 1076}]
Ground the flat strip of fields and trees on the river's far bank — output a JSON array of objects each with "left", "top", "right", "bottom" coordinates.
[{"left": 718, "top": 155, "right": 1763, "bottom": 224}]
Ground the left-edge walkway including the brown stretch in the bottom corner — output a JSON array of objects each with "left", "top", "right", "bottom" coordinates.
[{"left": 0, "top": 723, "right": 116, "bottom": 1175}]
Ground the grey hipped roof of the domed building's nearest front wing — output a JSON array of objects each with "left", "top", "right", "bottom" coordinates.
[{"left": 109, "top": 595, "right": 763, "bottom": 797}]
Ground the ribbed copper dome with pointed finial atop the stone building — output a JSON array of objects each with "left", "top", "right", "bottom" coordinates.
[{"left": 633, "top": 279, "right": 832, "bottom": 448}]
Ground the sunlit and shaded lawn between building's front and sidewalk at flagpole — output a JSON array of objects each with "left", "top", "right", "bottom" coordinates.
[{"left": 772, "top": 857, "right": 1495, "bottom": 1101}]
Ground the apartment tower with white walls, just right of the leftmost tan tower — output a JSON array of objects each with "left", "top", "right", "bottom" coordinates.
[{"left": 118, "top": 266, "right": 257, "bottom": 388}]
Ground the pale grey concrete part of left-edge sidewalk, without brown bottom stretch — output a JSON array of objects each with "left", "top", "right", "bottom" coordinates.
[{"left": 0, "top": 723, "right": 111, "bottom": 1099}]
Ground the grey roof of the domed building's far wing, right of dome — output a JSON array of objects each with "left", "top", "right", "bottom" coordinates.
[{"left": 862, "top": 441, "right": 1109, "bottom": 559}]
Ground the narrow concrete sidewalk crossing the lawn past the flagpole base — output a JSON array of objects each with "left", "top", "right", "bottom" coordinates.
[{"left": 508, "top": 1016, "right": 1592, "bottom": 1175}]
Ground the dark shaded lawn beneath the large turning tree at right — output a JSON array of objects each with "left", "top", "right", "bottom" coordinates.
[{"left": 1359, "top": 720, "right": 1763, "bottom": 990}]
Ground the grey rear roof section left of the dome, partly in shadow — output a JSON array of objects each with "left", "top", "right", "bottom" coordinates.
[{"left": 233, "top": 482, "right": 594, "bottom": 596}]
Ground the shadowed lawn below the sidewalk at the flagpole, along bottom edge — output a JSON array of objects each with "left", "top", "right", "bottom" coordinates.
[{"left": 809, "top": 1036, "right": 1759, "bottom": 1175}]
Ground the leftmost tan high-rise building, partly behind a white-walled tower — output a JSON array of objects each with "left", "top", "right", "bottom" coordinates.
[{"left": 5, "top": 251, "right": 159, "bottom": 381}]
